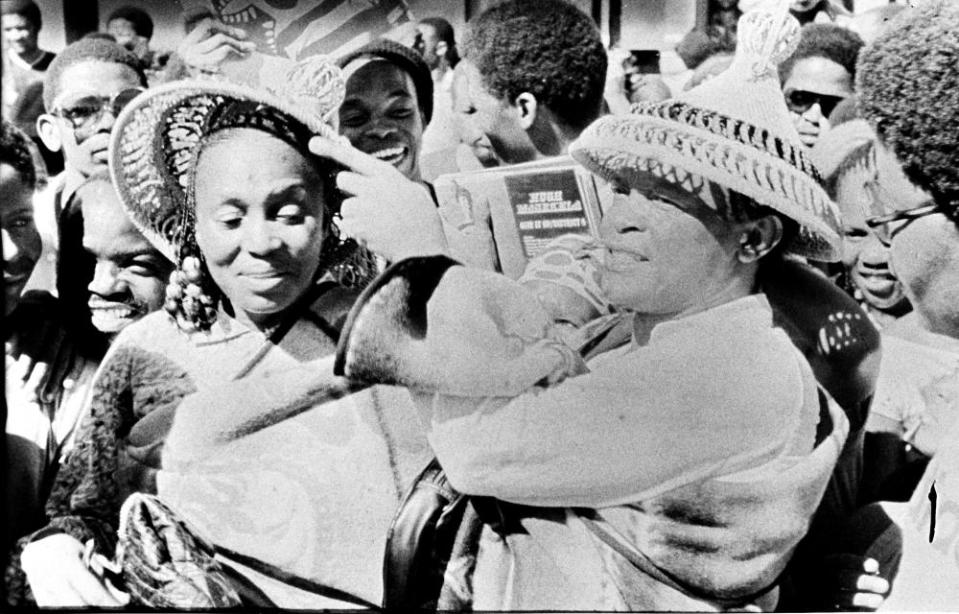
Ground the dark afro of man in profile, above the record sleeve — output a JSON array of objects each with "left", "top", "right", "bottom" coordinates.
[{"left": 465, "top": 0, "right": 607, "bottom": 129}]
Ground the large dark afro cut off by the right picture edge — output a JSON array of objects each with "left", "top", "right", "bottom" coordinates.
[{"left": 856, "top": 0, "right": 959, "bottom": 204}]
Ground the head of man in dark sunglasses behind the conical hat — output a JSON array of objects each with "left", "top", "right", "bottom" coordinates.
[{"left": 779, "top": 24, "right": 863, "bottom": 147}]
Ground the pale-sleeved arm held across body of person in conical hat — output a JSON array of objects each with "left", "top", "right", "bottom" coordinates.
[{"left": 430, "top": 322, "right": 812, "bottom": 507}]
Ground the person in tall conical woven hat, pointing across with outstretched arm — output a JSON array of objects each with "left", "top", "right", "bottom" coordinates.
[{"left": 313, "top": 1, "right": 888, "bottom": 611}]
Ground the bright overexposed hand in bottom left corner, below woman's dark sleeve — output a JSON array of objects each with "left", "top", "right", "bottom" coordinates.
[{"left": 20, "top": 534, "right": 130, "bottom": 608}]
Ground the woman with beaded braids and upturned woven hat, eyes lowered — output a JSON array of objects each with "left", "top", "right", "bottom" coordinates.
[{"left": 14, "top": 59, "right": 429, "bottom": 609}]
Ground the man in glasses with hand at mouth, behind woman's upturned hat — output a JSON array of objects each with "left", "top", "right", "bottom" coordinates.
[{"left": 29, "top": 39, "right": 146, "bottom": 292}]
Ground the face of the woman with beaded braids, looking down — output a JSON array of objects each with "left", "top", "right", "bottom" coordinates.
[{"left": 195, "top": 128, "right": 326, "bottom": 326}]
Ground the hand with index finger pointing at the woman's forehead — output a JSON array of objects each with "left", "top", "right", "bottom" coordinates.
[{"left": 310, "top": 137, "right": 447, "bottom": 262}]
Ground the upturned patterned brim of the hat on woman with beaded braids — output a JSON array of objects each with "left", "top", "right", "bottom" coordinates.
[{"left": 108, "top": 80, "right": 341, "bottom": 262}]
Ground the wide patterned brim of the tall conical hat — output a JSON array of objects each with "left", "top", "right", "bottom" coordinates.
[{"left": 570, "top": 114, "right": 840, "bottom": 262}]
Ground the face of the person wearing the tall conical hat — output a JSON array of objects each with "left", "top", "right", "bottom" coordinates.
[{"left": 600, "top": 175, "right": 741, "bottom": 314}]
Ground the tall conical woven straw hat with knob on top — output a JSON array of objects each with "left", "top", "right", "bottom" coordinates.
[{"left": 570, "top": 2, "right": 840, "bottom": 261}]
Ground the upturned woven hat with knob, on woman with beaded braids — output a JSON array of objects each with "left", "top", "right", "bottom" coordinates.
[{"left": 109, "top": 56, "right": 345, "bottom": 262}]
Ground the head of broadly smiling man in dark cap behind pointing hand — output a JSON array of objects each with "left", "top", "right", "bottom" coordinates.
[{"left": 338, "top": 39, "right": 433, "bottom": 181}]
